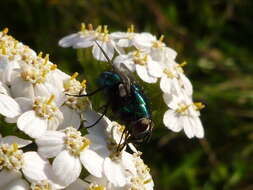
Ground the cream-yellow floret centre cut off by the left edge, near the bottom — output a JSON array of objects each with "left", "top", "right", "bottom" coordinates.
[{"left": 0, "top": 143, "right": 24, "bottom": 171}]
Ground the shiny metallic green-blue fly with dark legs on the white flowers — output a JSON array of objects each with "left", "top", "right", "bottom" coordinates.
[{"left": 68, "top": 42, "right": 153, "bottom": 151}]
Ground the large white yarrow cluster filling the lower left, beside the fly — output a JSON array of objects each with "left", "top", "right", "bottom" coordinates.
[{"left": 0, "top": 29, "right": 154, "bottom": 190}]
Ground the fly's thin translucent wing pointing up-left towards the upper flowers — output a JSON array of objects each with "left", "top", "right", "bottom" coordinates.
[{"left": 95, "top": 41, "right": 132, "bottom": 94}]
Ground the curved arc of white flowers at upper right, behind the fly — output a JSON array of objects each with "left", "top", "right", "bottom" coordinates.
[{"left": 59, "top": 24, "right": 204, "bottom": 138}]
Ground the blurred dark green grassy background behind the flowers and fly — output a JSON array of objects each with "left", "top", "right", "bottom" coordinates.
[{"left": 0, "top": 0, "right": 253, "bottom": 190}]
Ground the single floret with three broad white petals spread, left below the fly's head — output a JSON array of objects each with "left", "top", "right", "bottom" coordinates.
[{"left": 36, "top": 127, "right": 103, "bottom": 185}]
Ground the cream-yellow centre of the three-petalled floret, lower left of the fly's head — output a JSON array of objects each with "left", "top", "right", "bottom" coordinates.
[{"left": 64, "top": 127, "right": 91, "bottom": 156}]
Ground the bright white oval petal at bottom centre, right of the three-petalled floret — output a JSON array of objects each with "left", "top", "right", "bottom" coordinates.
[{"left": 104, "top": 158, "right": 126, "bottom": 187}]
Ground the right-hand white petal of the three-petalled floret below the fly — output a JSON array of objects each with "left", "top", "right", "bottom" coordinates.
[{"left": 80, "top": 149, "right": 104, "bottom": 177}]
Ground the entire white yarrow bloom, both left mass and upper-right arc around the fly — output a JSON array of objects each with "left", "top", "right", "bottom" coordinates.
[{"left": 0, "top": 24, "right": 207, "bottom": 190}]
